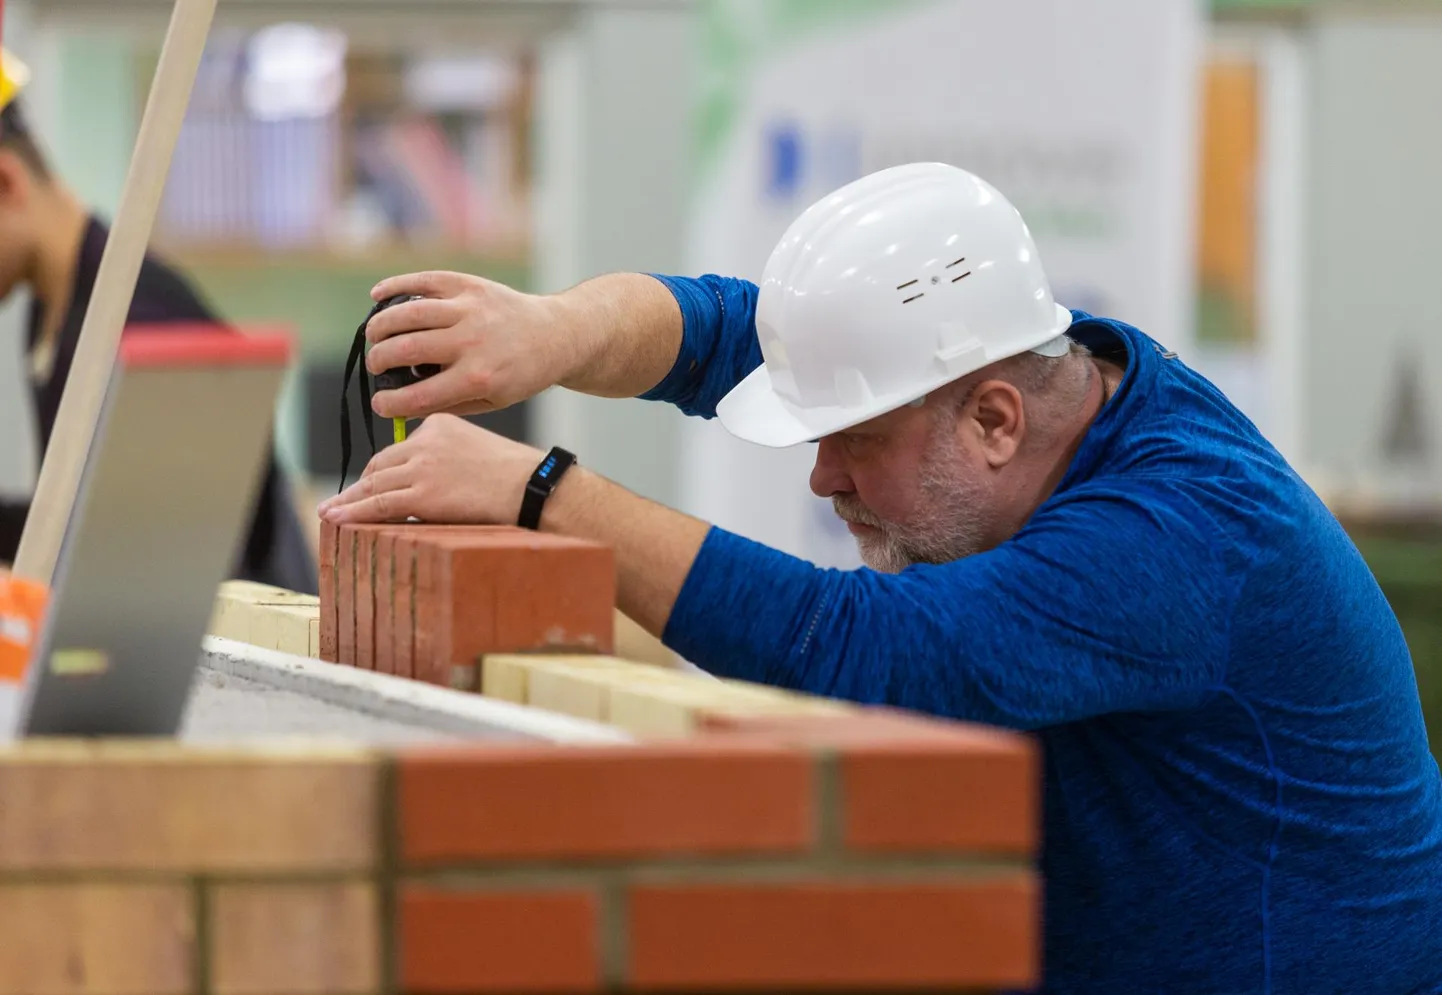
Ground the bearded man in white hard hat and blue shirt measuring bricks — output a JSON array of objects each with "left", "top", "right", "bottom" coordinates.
[{"left": 320, "top": 158, "right": 1442, "bottom": 995}]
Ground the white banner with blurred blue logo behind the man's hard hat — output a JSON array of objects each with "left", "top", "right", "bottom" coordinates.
[{"left": 682, "top": 0, "right": 1204, "bottom": 567}]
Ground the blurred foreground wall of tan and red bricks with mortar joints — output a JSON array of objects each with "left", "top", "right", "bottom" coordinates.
[{"left": 0, "top": 709, "right": 1040, "bottom": 995}]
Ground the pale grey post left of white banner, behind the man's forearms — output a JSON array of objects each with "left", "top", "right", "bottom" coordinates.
[{"left": 535, "top": 4, "right": 695, "bottom": 503}]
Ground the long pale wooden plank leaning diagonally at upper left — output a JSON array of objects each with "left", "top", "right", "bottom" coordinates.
[{"left": 14, "top": 0, "right": 216, "bottom": 585}]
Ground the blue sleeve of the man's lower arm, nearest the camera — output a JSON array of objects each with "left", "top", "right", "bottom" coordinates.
[{"left": 665, "top": 485, "right": 1233, "bottom": 730}]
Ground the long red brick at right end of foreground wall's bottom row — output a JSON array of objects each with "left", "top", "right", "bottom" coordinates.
[{"left": 627, "top": 872, "right": 1040, "bottom": 991}]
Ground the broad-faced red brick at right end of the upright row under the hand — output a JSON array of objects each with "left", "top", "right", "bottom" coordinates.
[{"left": 415, "top": 531, "right": 616, "bottom": 684}]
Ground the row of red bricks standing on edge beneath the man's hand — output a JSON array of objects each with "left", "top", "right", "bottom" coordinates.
[{"left": 319, "top": 523, "right": 616, "bottom": 680}]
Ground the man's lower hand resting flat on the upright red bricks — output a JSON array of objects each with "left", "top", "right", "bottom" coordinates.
[{"left": 319, "top": 415, "right": 544, "bottom": 525}]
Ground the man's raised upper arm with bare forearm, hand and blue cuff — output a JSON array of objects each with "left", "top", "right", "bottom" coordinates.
[{"left": 366, "top": 266, "right": 760, "bottom": 418}]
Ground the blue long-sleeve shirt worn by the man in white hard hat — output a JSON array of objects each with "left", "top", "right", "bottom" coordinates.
[{"left": 645, "top": 275, "right": 1442, "bottom": 995}]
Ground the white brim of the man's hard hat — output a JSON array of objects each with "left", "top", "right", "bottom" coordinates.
[{"left": 717, "top": 304, "right": 1071, "bottom": 448}]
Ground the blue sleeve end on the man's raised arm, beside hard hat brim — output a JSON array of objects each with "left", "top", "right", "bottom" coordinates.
[{"left": 640, "top": 274, "right": 761, "bottom": 418}]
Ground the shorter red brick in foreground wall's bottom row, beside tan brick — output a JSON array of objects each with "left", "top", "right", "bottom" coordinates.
[{"left": 397, "top": 885, "right": 601, "bottom": 995}]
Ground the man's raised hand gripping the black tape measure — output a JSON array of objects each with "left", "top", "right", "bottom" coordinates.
[{"left": 366, "top": 273, "right": 587, "bottom": 418}]
